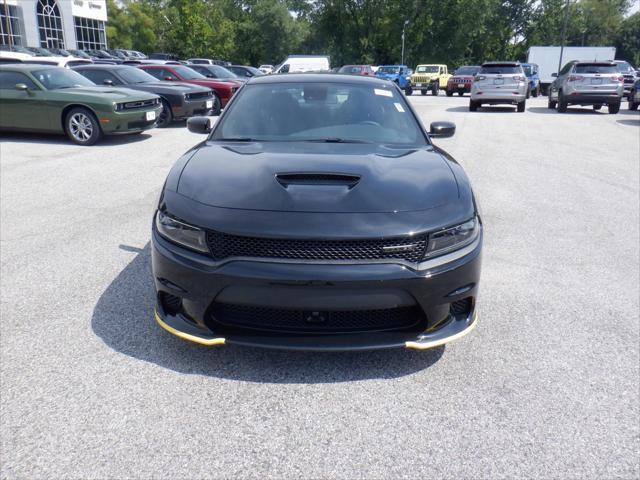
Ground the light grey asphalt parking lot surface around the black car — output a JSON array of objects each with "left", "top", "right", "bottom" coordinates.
[{"left": 0, "top": 95, "right": 640, "bottom": 479}]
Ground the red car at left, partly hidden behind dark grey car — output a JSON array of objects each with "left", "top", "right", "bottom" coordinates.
[{"left": 138, "top": 64, "right": 242, "bottom": 115}]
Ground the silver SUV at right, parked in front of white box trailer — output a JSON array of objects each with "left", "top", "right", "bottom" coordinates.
[{"left": 548, "top": 60, "right": 624, "bottom": 113}]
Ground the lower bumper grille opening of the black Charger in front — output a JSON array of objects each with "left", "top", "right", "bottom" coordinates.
[{"left": 208, "top": 303, "right": 424, "bottom": 333}]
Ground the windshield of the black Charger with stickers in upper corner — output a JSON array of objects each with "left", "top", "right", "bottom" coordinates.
[{"left": 212, "top": 82, "right": 427, "bottom": 145}]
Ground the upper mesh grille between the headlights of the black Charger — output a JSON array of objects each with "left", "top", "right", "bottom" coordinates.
[{"left": 207, "top": 232, "right": 427, "bottom": 262}]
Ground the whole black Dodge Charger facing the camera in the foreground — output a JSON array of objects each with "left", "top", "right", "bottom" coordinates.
[{"left": 152, "top": 74, "right": 483, "bottom": 350}]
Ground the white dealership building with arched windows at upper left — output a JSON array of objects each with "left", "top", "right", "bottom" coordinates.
[{"left": 0, "top": 0, "right": 107, "bottom": 50}]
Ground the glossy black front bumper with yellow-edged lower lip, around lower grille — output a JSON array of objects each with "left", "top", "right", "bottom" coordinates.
[{"left": 152, "top": 230, "right": 482, "bottom": 351}]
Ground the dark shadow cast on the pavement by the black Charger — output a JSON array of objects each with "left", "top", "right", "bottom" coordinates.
[{"left": 91, "top": 244, "right": 445, "bottom": 383}]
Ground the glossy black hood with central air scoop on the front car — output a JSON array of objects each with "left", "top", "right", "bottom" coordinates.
[{"left": 177, "top": 142, "right": 459, "bottom": 213}]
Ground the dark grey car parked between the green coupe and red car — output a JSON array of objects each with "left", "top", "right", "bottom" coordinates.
[{"left": 73, "top": 65, "right": 214, "bottom": 128}]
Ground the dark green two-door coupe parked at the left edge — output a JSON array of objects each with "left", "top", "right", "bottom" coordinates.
[{"left": 0, "top": 64, "right": 162, "bottom": 145}]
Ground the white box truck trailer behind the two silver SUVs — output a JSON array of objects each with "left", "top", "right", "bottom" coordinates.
[{"left": 527, "top": 46, "right": 616, "bottom": 95}]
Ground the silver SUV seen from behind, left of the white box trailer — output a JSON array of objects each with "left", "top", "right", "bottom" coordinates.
[{"left": 469, "top": 62, "right": 528, "bottom": 112}]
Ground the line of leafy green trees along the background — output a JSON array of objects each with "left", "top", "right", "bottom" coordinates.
[{"left": 107, "top": 0, "right": 640, "bottom": 66}]
